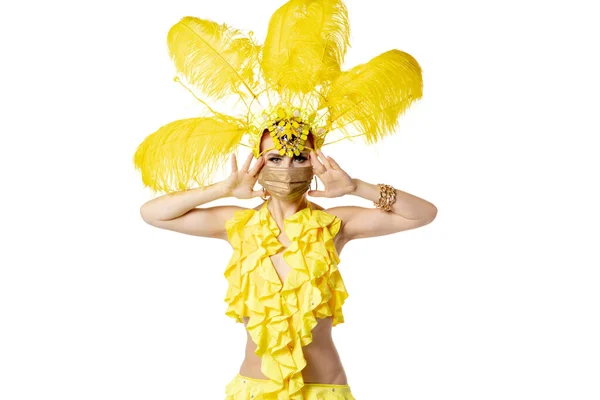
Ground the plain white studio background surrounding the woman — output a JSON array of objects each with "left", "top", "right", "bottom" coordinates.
[{"left": 0, "top": 0, "right": 600, "bottom": 400}]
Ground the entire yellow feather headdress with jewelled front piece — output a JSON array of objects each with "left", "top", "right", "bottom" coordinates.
[{"left": 133, "top": 0, "right": 423, "bottom": 193}]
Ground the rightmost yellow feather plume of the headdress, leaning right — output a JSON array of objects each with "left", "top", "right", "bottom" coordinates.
[{"left": 319, "top": 50, "right": 423, "bottom": 144}]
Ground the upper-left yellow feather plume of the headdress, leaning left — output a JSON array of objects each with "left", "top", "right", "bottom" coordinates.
[{"left": 167, "top": 17, "right": 260, "bottom": 99}]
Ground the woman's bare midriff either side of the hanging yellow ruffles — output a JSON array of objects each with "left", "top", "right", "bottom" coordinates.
[{"left": 240, "top": 317, "right": 348, "bottom": 385}]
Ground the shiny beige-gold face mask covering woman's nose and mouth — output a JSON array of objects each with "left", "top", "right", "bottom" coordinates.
[{"left": 258, "top": 165, "right": 314, "bottom": 201}]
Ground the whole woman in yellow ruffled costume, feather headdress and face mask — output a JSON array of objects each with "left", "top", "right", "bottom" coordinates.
[{"left": 134, "top": 0, "right": 437, "bottom": 400}]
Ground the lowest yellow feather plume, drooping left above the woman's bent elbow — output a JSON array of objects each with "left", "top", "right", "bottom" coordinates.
[{"left": 133, "top": 114, "right": 248, "bottom": 193}]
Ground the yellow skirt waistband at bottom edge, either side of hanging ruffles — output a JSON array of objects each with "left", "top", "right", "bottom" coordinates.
[{"left": 225, "top": 374, "right": 356, "bottom": 400}]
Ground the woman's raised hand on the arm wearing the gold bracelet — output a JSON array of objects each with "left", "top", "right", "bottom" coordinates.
[{"left": 308, "top": 150, "right": 356, "bottom": 197}]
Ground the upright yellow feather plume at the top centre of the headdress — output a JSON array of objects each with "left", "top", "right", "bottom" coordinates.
[{"left": 261, "top": 0, "right": 350, "bottom": 93}]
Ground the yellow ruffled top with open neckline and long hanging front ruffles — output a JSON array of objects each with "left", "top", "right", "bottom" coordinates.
[{"left": 224, "top": 201, "right": 348, "bottom": 400}]
